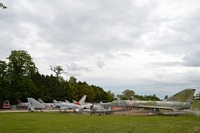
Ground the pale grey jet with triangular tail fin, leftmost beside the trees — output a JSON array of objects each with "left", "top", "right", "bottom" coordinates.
[{"left": 27, "top": 98, "right": 45, "bottom": 112}]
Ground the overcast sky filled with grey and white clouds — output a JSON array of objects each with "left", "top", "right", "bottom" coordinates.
[{"left": 0, "top": 0, "right": 200, "bottom": 99}]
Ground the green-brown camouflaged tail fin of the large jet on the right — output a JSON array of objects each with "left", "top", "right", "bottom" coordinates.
[{"left": 165, "top": 89, "right": 195, "bottom": 103}]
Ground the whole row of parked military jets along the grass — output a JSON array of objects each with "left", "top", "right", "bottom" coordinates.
[{"left": 27, "top": 89, "right": 195, "bottom": 114}]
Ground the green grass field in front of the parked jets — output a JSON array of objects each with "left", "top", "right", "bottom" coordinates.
[{"left": 0, "top": 112, "right": 200, "bottom": 133}]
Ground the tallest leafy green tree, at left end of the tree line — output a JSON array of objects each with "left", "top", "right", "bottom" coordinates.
[{"left": 7, "top": 50, "right": 37, "bottom": 100}]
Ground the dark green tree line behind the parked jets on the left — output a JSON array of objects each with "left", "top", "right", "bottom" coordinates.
[{"left": 0, "top": 50, "right": 115, "bottom": 104}]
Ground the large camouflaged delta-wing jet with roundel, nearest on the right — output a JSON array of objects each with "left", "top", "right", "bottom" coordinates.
[{"left": 102, "top": 89, "right": 195, "bottom": 114}]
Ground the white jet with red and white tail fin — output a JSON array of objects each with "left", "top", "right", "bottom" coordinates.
[{"left": 51, "top": 95, "right": 86, "bottom": 112}]
